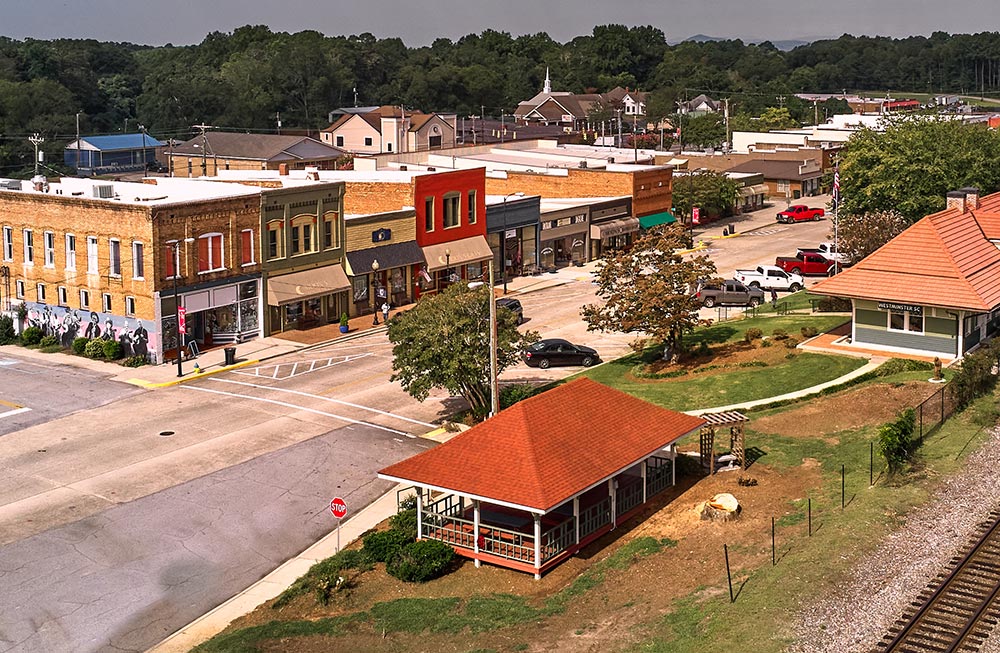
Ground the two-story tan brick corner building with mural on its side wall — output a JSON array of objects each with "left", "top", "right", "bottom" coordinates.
[{"left": 0, "top": 178, "right": 261, "bottom": 362}]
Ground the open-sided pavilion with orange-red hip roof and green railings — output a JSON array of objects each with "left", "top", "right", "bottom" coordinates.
[{"left": 379, "top": 379, "right": 706, "bottom": 578}]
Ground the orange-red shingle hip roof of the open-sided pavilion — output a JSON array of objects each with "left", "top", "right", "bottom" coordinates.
[{"left": 379, "top": 379, "right": 705, "bottom": 512}]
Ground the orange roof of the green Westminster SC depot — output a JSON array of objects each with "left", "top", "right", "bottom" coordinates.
[{"left": 812, "top": 193, "right": 1000, "bottom": 311}]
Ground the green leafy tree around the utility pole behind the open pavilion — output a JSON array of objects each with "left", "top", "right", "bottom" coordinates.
[{"left": 389, "top": 284, "right": 538, "bottom": 416}]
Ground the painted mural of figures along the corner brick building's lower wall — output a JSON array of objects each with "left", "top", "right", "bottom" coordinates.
[{"left": 24, "top": 302, "right": 156, "bottom": 363}]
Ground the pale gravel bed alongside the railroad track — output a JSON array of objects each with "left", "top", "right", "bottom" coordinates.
[{"left": 787, "top": 428, "right": 1000, "bottom": 653}]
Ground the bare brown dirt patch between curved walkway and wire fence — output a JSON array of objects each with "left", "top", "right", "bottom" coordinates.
[{"left": 751, "top": 381, "right": 940, "bottom": 438}]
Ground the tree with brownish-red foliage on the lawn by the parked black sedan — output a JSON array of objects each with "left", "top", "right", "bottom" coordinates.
[{"left": 581, "top": 223, "right": 715, "bottom": 360}]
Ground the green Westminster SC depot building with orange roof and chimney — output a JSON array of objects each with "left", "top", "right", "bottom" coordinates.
[{"left": 811, "top": 188, "right": 1000, "bottom": 360}]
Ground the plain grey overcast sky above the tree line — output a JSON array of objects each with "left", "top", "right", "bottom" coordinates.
[{"left": 0, "top": 0, "right": 1000, "bottom": 46}]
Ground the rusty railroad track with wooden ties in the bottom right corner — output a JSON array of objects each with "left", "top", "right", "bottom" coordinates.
[{"left": 874, "top": 510, "right": 1000, "bottom": 653}]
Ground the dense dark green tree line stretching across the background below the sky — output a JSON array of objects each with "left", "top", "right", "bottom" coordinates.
[{"left": 0, "top": 25, "right": 1000, "bottom": 176}]
